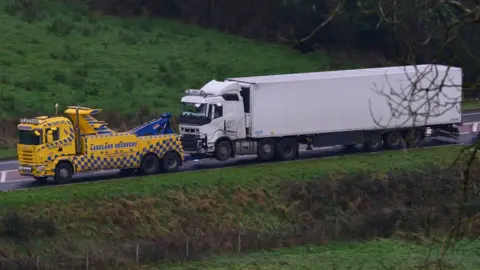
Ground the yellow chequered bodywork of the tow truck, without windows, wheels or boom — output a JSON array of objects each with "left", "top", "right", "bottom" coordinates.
[{"left": 17, "top": 108, "right": 184, "bottom": 177}]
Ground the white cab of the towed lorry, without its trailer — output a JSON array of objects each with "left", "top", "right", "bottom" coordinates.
[{"left": 179, "top": 80, "right": 248, "bottom": 161}]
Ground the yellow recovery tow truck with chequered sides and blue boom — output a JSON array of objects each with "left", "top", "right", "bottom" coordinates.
[{"left": 17, "top": 106, "right": 184, "bottom": 184}]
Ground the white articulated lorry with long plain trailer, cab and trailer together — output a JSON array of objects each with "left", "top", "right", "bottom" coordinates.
[{"left": 179, "top": 65, "right": 462, "bottom": 161}]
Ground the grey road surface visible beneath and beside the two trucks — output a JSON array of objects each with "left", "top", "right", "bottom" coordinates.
[{"left": 0, "top": 112, "right": 480, "bottom": 191}]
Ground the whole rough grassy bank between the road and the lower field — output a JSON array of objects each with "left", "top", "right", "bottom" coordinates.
[{"left": 0, "top": 146, "right": 480, "bottom": 269}]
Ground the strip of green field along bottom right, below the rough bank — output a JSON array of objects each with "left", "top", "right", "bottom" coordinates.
[{"left": 162, "top": 240, "right": 480, "bottom": 270}]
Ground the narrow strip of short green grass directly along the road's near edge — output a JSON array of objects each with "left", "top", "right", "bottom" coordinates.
[{"left": 0, "top": 146, "right": 464, "bottom": 207}]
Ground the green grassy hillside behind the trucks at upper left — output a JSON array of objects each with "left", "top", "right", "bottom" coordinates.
[{"left": 0, "top": 0, "right": 352, "bottom": 118}]
